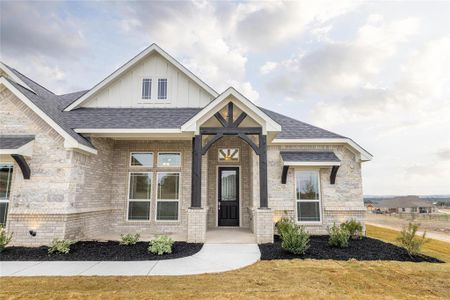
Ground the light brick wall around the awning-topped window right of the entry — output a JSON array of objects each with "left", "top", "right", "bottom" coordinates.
[{"left": 268, "top": 145, "right": 366, "bottom": 234}]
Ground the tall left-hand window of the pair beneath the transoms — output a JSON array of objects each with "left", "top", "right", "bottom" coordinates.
[{"left": 128, "top": 172, "right": 152, "bottom": 221}]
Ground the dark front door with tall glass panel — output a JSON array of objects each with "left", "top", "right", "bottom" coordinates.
[{"left": 218, "top": 167, "right": 239, "bottom": 226}]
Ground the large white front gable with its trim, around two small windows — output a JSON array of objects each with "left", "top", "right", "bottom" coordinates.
[{"left": 65, "top": 44, "right": 217, "bottom": 111}]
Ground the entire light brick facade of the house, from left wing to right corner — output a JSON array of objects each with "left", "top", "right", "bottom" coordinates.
[{"left": 0, "top": 89, "right": 365, "bottom": 246}]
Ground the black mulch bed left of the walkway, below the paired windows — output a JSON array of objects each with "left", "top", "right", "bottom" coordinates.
[{"left": 0, "top": 241, "right": 203, "bottom": 261}]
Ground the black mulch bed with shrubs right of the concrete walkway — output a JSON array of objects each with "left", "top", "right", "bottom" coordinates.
[{"left": 259, "top": 236, "right": 443, "bottom": 263}]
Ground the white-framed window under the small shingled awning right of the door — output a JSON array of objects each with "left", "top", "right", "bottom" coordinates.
[{"left": 295, "top": 171, "right": 321, "bottom": 222}]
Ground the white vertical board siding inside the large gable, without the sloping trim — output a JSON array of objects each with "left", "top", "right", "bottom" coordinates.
[{"left": 81, "top": 53, "right": 213, "bottom": 107}]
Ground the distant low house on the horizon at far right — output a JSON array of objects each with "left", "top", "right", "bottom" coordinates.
[{"left": 375, "top": 196, "right": 434, "bottom": 213}]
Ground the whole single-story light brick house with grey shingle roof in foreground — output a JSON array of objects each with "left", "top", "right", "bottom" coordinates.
[{"left": 0, "top": 44, "right": 372, "bottom": 245}]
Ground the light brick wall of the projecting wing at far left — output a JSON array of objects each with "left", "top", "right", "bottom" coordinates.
[{"left": 0, "top": 89, "right": 116, "bottom": 246}]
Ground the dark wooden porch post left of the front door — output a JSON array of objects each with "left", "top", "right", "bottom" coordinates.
[{"left": 191, "top": 135, "right": 202, "bottom": 208}]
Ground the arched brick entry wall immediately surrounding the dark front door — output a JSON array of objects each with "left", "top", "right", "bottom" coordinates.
[{"left": 207, "top": 136, "right": 253, "bottom": 228}]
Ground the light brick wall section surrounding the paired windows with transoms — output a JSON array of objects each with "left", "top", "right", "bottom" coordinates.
[{"left": 109, "top": 140, "right": 194, "bottom": 240}]
